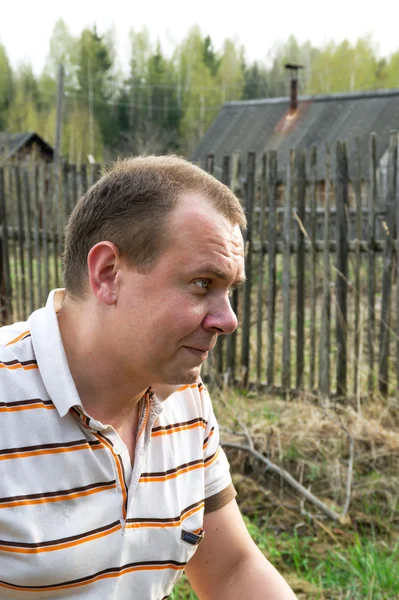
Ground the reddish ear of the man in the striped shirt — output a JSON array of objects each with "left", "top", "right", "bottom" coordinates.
[{"left": 87, "top": 242, "right": 119, "bottom": 305}]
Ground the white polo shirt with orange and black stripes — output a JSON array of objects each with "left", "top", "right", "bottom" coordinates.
[{"left": 0, "top": 290, "right": 235, "bottom": 600}]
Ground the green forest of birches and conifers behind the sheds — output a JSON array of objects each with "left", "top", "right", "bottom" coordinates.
[{"left": 0, "top": 19, "right": 399, "bottom": 164}]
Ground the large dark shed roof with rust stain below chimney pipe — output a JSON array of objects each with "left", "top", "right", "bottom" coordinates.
[{"left": 190, "top": 89, "right": 399, "bottom": 177}]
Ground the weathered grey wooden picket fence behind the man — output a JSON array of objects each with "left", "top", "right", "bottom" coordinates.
[{"left": 0, "top": 133, "right": 399, "bottom": 402}]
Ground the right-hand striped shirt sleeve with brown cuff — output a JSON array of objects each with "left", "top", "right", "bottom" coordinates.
[{"left": 200, "top": 384, "right": 236, "bottom": 512}]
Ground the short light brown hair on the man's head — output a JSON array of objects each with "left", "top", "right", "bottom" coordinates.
[{"left": 63, "top": 155, "right": 246, "bottom": 297}]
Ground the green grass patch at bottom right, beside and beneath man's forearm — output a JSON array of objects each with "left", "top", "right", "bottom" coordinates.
[{"left": 170, "top": 519, "right": 399, "bottom": 600}]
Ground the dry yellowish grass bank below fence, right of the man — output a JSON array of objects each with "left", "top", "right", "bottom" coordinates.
[{"left": 213, "top": 391, "right": 399, "bottom": 537}]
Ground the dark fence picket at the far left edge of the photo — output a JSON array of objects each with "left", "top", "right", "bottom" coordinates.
[{"left": 0, "top": 167, "right": 12, "bottom": 326}]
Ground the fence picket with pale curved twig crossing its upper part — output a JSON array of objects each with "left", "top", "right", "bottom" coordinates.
[{"left": 296, "top": 150, "right": 306, "bottom": 389}]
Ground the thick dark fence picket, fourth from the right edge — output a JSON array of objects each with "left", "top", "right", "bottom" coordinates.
[{"left": 335, "top": 142, "right": 349, "bottom": 397}]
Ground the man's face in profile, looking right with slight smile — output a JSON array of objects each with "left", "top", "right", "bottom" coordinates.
[{"left": 111, "top": 194, "right": 244, "bottom": 385}]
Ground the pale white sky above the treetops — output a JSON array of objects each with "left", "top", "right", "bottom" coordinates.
[{"left": 0, "top": 0, "right": 399, "bottom": 74}]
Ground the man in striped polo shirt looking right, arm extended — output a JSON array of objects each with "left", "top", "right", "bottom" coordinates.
[{"left": 0, "top": 157, "right": 295, "bottom": 600}]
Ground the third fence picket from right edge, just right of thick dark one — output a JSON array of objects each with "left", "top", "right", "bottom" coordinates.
[{"left": 353, "top": 138, "right": 362, "bottom": 396}]
